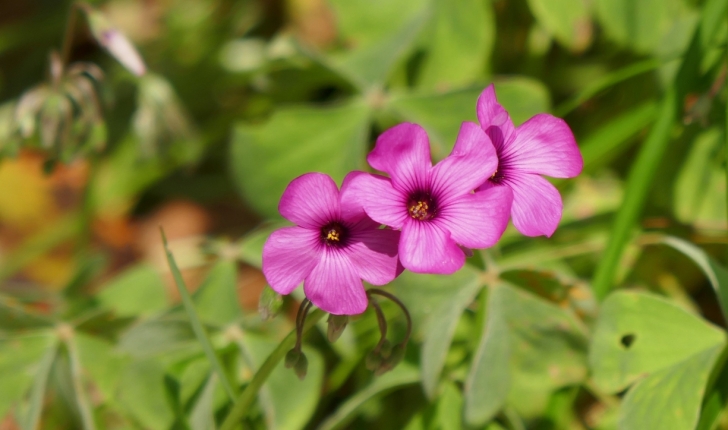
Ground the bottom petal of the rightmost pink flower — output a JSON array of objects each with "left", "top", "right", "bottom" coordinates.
[{"left": 506, "top": 171, "right": 563, "bottom": 237}]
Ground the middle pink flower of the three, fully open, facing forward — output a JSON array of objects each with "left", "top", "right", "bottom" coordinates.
[{"left": 342, "top": 122, "right": 512, "bottom": 274}]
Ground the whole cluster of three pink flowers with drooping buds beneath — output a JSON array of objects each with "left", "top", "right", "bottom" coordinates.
[{"left": 263, "top": 85, "right": 583, "bottom": 375}]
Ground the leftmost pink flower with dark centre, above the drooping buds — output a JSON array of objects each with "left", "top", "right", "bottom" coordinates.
[{"left": 263, "top": 173, "right": 403, "bottom": 315}]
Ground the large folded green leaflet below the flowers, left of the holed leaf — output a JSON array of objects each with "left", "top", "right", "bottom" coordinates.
[{"left": 465, "top": 284, "right": 587, "bottom": 425}]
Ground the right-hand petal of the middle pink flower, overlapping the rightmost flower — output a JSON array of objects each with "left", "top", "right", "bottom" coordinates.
[{"left": 435, "top": 186, "right": 513, "bottom": 248}]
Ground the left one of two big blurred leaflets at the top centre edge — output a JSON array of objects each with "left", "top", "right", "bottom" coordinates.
[{"left": 330, "top": 0, "right": 429, "bottom": 90}]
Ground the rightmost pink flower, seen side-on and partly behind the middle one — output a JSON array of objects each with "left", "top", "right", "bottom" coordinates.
[{"left": 477, "top": 84, "right": 584, "bottom": 236}]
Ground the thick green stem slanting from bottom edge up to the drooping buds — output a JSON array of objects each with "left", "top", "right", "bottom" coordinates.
[{"left": 220, "top": 309, "right": 324, "bottom": 430}]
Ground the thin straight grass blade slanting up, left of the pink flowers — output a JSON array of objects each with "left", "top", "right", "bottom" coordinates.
[{"left": 159, "top": 227, "right": 235, "bottom": 400}]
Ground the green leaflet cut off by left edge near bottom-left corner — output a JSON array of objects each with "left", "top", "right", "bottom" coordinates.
[{"left": 0, "top": 333, "right": 56, "bottom": 416}]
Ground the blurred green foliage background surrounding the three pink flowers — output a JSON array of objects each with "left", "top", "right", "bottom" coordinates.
[{"left": 0, "top": 0, "right": 728, "bottom": 430}]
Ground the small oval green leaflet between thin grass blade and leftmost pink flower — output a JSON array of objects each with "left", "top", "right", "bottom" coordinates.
[{"left": 193, "top": 260, "right": 242, "bottom": 326}]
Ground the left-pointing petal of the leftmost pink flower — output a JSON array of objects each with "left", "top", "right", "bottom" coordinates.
[{"left": 263, "top": 227, "right": 321, "bottom": 294}]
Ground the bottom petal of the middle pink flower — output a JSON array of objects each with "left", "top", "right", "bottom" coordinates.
[{"left": 399, "top": 218, "right": 465, "bottom": 274}]
